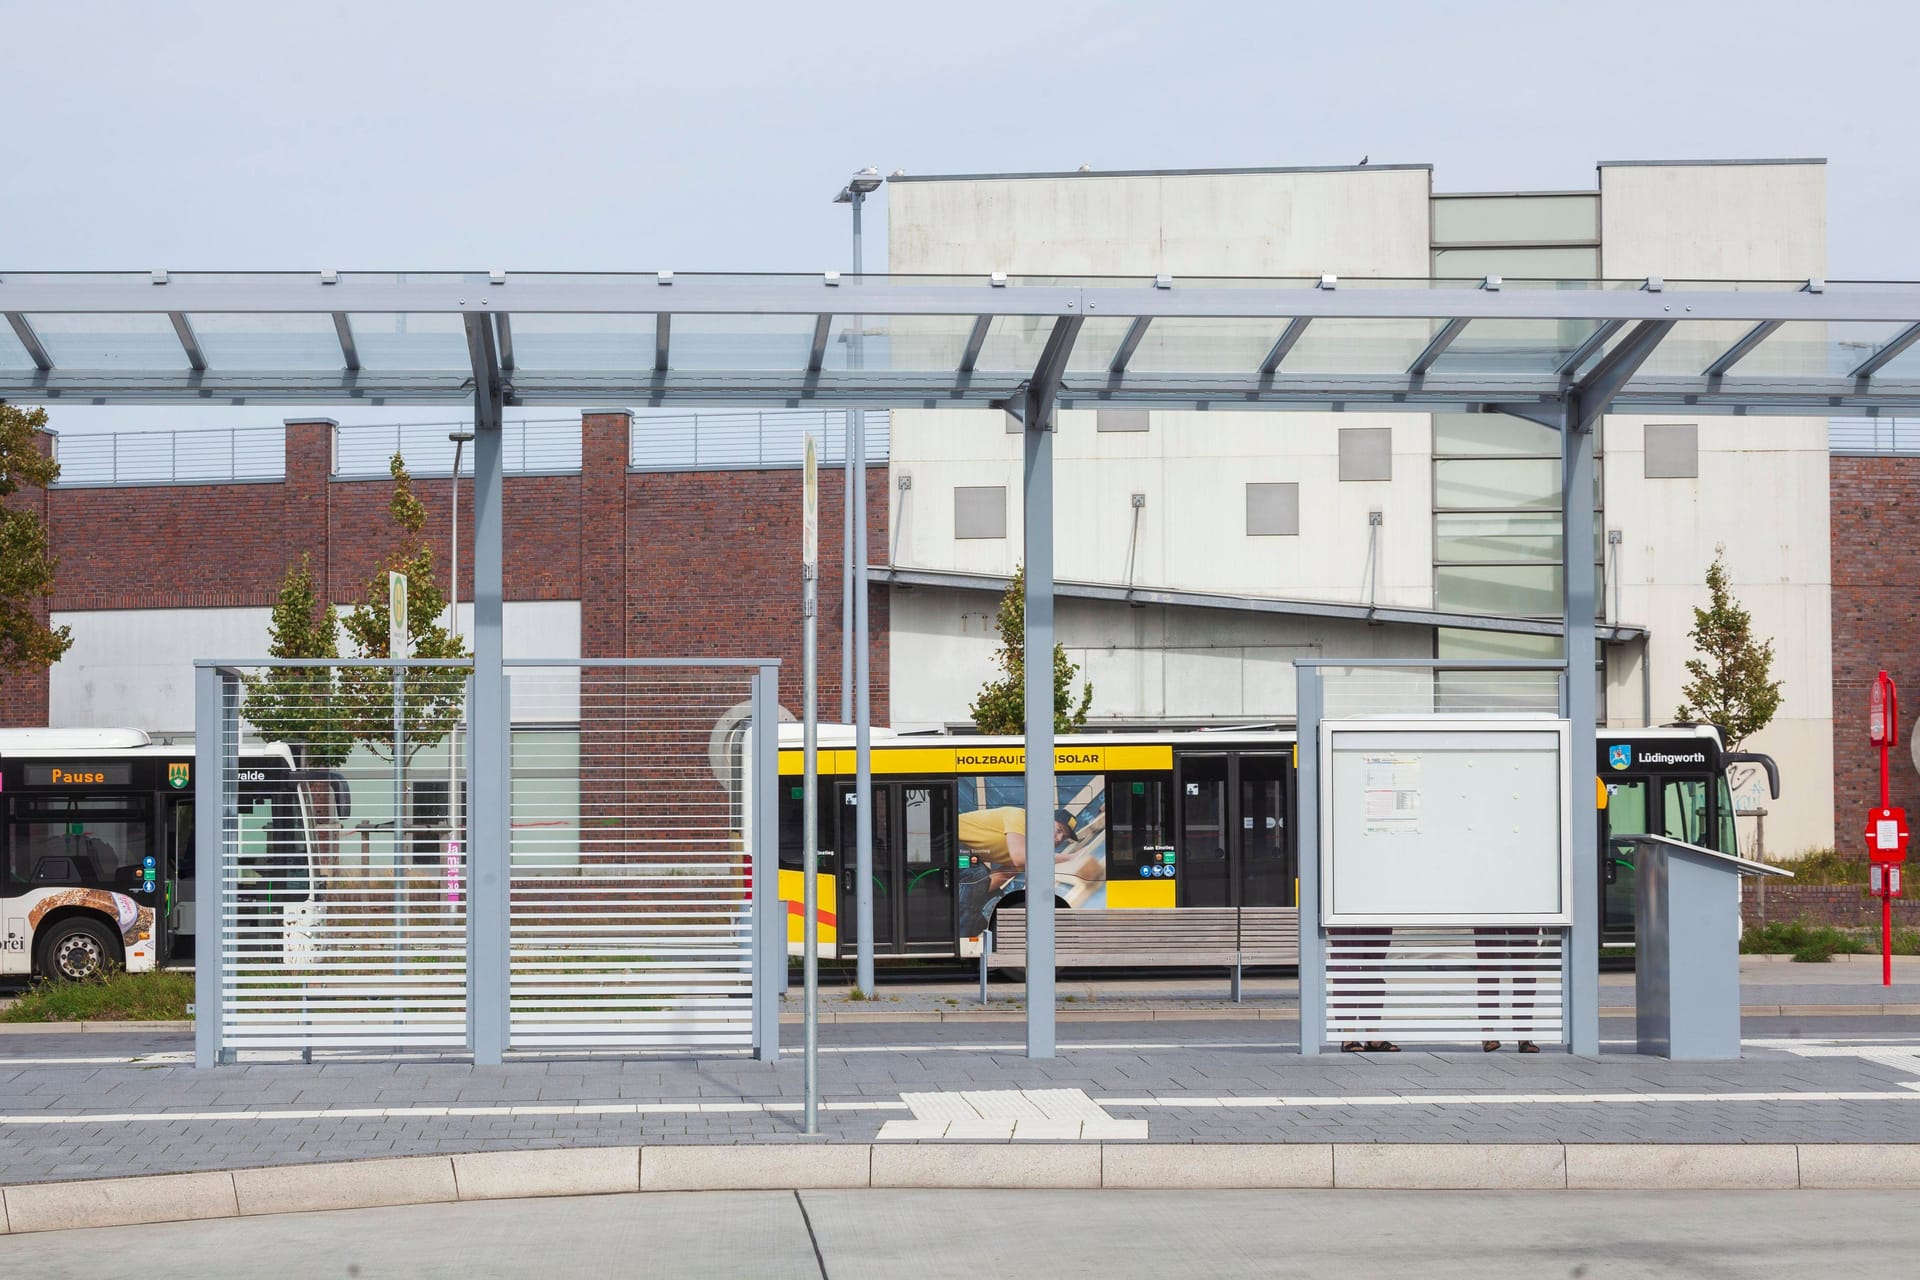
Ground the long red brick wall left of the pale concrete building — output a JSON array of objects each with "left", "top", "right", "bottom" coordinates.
[{"left": 0, "top": 415, "right": 889, "bottom": 723}]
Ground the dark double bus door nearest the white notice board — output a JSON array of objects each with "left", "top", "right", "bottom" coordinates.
[{"left": 1175, "top": 752, "right": 1294, "bottom": 906}]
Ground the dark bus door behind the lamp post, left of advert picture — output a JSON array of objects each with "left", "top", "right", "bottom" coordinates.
[{"left": 833, "top": 779, "right": 956, "bottom": 958}]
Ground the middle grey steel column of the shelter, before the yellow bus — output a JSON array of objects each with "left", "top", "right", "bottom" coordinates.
[{"left": 1021, "top": 383, "right": 1060, "bottom": 1057}]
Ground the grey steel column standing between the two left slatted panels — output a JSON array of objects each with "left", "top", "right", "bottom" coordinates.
[{"left": 467, "top": 317, "right": 513, "bottom": 1063}]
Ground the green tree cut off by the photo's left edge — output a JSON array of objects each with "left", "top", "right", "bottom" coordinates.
[{"left": 0, "top": 403, "right": 73, "bottom": 677}]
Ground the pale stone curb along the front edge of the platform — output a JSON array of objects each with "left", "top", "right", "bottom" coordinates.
[{"left": 0, "top": 1142, "right": 1920, "bottom": 1234}]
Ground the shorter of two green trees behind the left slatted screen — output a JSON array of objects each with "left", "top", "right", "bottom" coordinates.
[{"left": 246, "top": 555, "right": 353, "bottom": 768}]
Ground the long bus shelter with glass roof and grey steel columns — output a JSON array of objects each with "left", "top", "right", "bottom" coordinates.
[{"left": 0, "top": 271, "right": 1920, "bottom": 1061}]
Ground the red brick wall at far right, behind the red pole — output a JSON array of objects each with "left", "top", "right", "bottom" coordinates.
[{"left": 1830, "top": 457, "right": 1920, "bottom": 858}]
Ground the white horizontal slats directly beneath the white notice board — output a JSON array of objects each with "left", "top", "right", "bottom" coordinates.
[{"left": 1327, "top": 925, "right": 1567, "bottom": 1044}]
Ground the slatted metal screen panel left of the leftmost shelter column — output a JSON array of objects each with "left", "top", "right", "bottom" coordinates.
[{"left": 216, "top": 664, "right": 467, "bottom": 1050}]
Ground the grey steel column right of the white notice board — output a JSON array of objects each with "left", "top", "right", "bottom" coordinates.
[{"left": 1561, "top": 395, "right": 1599, "bottom": 1055}]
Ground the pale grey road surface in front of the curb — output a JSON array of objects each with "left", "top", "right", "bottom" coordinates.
[{"left": 0, "top": 1190, "right": 1920, "bottom": 1280}]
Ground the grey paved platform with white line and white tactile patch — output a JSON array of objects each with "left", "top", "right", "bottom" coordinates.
[{"left": 0, "top": 1017, "right": 1920, "bottom": 1184}]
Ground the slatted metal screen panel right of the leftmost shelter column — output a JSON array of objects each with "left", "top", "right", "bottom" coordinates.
[{"left": 509, "top": 664, "right": 753, "bottom": 1050}]
